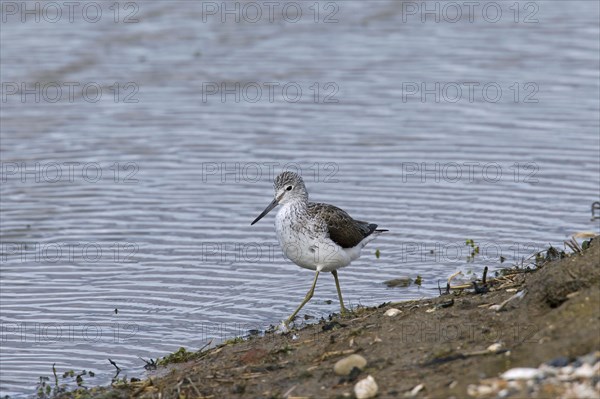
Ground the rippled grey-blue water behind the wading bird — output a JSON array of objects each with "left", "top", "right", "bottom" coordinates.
[{"left": 0, "top": 1, "right": 600, "bottom": 396}]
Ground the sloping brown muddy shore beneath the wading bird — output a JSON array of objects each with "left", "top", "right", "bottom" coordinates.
[{"left": 57, "top": 238, "right": 600, "bottom": 398}]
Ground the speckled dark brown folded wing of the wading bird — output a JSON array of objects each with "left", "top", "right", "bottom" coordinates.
[{"left": 308, "top": 202, "right": 377, "bottom": 248}]
